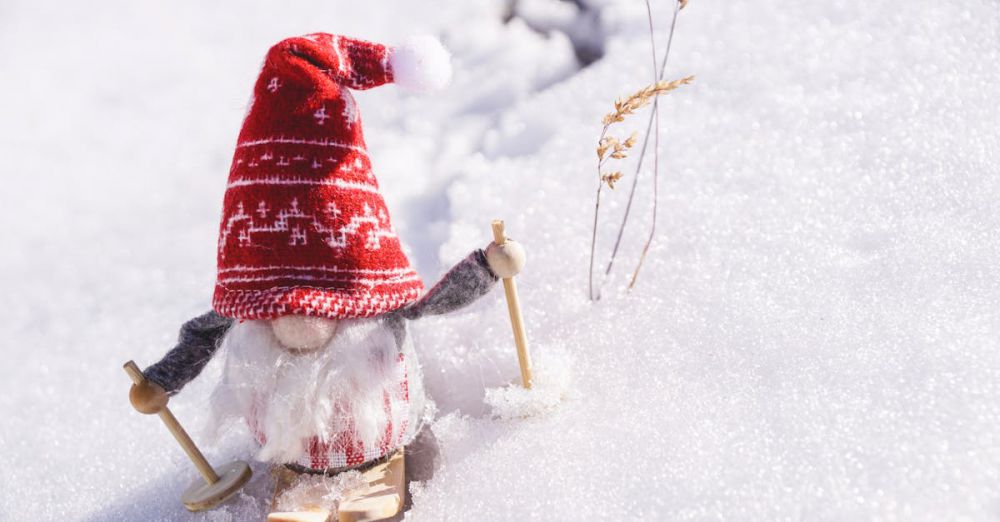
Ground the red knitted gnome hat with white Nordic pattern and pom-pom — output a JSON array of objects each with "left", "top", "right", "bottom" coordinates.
[{"left": 213, "top": 33, "right": 450, "bottom": 319}]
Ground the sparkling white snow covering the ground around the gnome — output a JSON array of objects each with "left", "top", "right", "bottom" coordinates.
[{"left": 0, "top": 0, "right": 1000, "bottom": 521}]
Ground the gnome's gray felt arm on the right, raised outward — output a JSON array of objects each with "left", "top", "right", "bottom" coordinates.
[{"left": 399, "top": 250, "right": 497, "bottom": 319}]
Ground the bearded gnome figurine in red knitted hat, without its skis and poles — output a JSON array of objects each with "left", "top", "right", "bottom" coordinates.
[{"left": 129, "top": 33, "right": 525, "bottom": 516}]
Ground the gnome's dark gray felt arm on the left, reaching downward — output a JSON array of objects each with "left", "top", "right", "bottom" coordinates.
[{"left": 143, "top": 311, "right": 233, "bottom": 395}]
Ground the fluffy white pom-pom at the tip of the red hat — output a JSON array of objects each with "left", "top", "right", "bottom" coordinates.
[{"left": 389, "top": 36, "right": 451, "bottom": 92}]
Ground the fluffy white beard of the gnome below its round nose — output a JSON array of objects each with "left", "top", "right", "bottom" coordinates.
[{"left": 211, "top": 319, "right": 423, "bottom": 463}]
